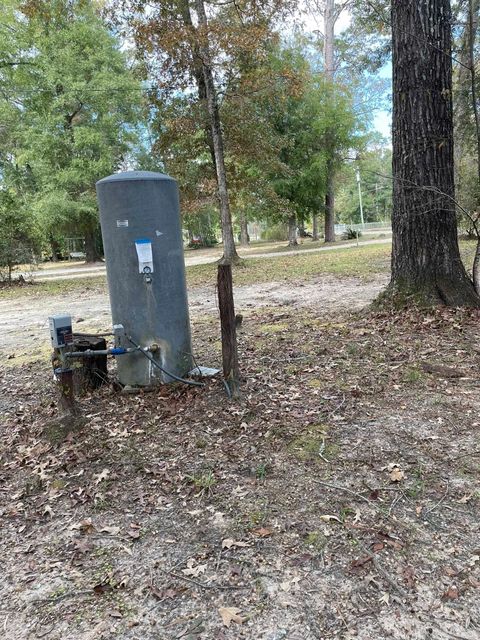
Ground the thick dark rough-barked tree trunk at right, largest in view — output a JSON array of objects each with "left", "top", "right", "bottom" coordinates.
[{"left": 390, "top": 0, "right": 480, "bottom": 306}]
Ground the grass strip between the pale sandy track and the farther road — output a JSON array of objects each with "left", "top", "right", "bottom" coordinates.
[{"left": 0, "top": 241, "right": 476, "bottom": 300}]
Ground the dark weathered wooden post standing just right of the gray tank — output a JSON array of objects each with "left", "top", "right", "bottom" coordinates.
[{"left": 217, "top": 264, "right": 240, "bottom": 398}]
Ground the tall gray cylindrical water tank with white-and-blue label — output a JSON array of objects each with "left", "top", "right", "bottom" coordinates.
[{"left": 97, "top": 171, "right": 192, "bottom": 386}]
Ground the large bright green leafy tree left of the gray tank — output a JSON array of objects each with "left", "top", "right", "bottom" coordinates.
[{"left": 2, "top": 0, "right": 141, "bottom": 261}]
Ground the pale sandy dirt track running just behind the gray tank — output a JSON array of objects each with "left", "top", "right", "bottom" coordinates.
[{"left": 0, "top": 275, "right": 385, "bottom": 364}]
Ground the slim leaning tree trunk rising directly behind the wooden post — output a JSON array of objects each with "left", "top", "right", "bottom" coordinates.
[{"left": 195, "top": 0, "right": 240, "bottom": 263}]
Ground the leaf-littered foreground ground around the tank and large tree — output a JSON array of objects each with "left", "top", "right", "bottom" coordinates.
[{"left": 0, "top": 298, "right": 480, "bottom": 640}]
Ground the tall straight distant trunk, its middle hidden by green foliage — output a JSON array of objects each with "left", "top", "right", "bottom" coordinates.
[{"left": 323, "top": 0, "right": 336, "bottom": 242}]
